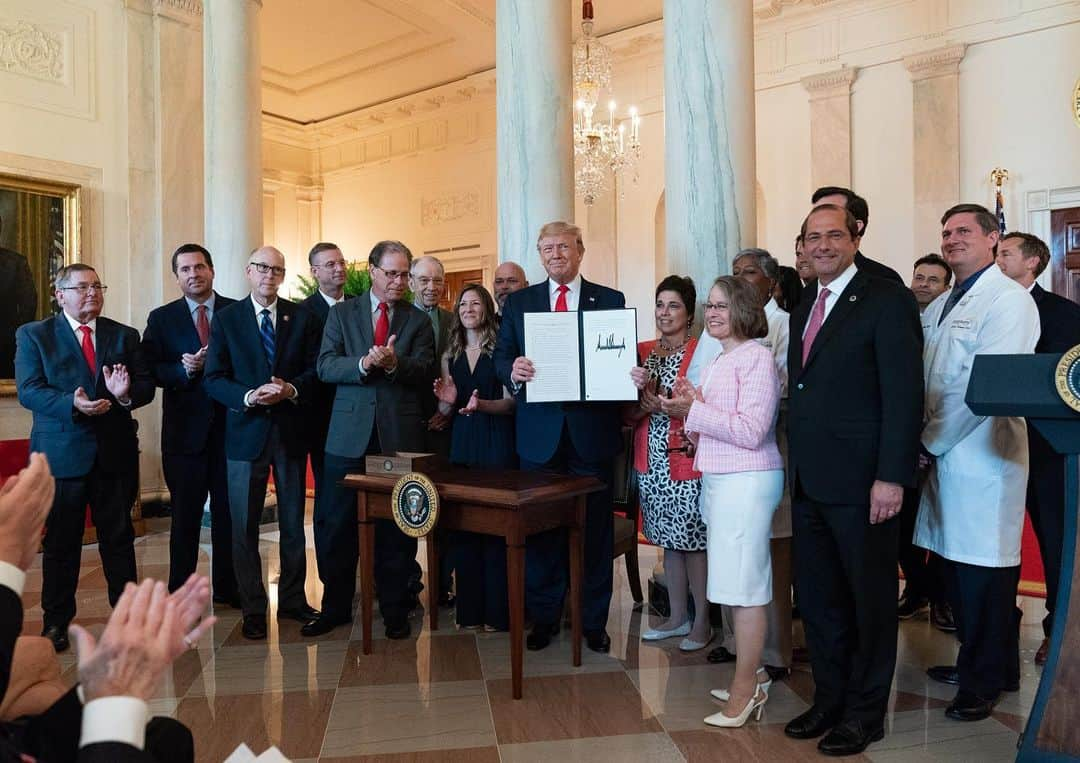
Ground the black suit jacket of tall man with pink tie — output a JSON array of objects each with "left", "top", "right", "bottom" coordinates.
[{"left": 787, "top": 270, "right": 922, "bottom": 505}]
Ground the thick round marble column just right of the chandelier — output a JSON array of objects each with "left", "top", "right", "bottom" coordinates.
[{"left": 664, "top": 0, "right": 756, "bottom": 287}]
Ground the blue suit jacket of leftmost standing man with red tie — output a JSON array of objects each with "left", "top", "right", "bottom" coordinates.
[{"left": 15, "top": 314, "right": 153, "bottom": 479}]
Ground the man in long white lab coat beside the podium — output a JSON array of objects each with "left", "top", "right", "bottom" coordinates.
[{"left": 915, "top": 204, "right": 1039, "bottom": 721}]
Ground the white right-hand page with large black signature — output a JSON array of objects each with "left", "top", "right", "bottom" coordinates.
[{"left": 581, "top": 308, "right": 637, "bottom": 400}]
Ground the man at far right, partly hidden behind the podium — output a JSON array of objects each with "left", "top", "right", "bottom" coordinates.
[{"left": 997, "top": 231, "right": 1080, "bottom": 665}]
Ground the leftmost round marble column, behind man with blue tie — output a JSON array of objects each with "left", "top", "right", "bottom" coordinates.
[{"left": 203, "top": 0, "right": 262, "bottom": 297}]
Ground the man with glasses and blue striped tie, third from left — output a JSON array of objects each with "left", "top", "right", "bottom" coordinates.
[{"left": 205, "top": 246, "right": 319, "bottom": 639}]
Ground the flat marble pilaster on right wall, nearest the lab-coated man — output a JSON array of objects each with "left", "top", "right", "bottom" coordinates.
[{"left": 904, "top": 44, "right": 964, "bottom": 256}]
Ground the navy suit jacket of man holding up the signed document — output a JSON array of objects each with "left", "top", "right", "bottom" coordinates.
[{"left": 495, "top": 279, "right": 626, "bottom": 463}]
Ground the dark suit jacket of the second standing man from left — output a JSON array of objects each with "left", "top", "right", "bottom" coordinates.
[{"left": 143, "top": 294, "right": 235, "bottom": 455}]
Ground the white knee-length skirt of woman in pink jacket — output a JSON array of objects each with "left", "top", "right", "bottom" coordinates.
[{"left": 701, "top": 469, "right": 784, "bottom": 606}]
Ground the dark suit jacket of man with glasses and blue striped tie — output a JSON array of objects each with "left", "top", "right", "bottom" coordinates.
[{"left": 204, "top": 297, "right": 320, "bottom": 461}]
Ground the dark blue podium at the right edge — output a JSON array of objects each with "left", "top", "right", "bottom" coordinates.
[{"left": 966, "top": 351, "right": 1080, "bottom": 763}]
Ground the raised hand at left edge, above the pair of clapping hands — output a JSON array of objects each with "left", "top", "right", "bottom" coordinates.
[{"left": 0, "top": 453, "right": 56, "bottom": 572}]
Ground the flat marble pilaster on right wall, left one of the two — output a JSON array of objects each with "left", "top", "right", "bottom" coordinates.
[{"left": 801, "top": 67, "right": 856, "bottom": 188}]
